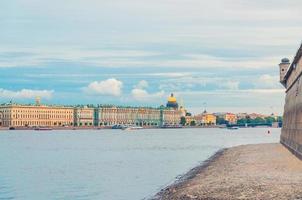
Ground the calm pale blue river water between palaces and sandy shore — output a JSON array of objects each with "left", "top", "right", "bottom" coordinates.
[{"left": 0, "top": 128, "right": 280, "bottom": 200}]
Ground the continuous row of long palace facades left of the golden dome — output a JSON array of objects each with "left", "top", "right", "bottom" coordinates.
[{"left": 0, "top": 104, "right": 181, "bottom": 127}]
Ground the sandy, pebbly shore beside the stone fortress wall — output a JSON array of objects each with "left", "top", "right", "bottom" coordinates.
[{"left": 153, "top": 144, "right": 302, "bottom": 200}]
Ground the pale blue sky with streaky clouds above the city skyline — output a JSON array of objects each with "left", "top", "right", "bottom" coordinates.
[{"left": 0, "top": 0, "right": 302, "bottom": 114}]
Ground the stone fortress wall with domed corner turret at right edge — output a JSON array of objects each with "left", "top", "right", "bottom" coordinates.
[{"left": 279, "top": 45, "right": 302, "bottom": 159}]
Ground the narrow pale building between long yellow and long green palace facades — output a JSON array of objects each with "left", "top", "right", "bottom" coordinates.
[{"left": 74, "top": 106, "right": 94, "bottom": 127}]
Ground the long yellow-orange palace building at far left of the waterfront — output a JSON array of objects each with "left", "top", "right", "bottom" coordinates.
[{"left": 0, "top": 104, "right": 74, "bottom": 127}]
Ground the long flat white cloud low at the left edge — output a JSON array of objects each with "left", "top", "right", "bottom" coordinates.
[{"left": 0, "top": 88, "right": 54, "bottom": 99}]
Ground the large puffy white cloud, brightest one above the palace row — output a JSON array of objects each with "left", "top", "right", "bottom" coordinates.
[{"left": 83, "top": 78, "right": 123, "bottom": 96}]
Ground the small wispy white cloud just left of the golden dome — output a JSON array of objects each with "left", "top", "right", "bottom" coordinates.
[{"left": 131, "top": 80, "right": 165, "bottom": 102}]
